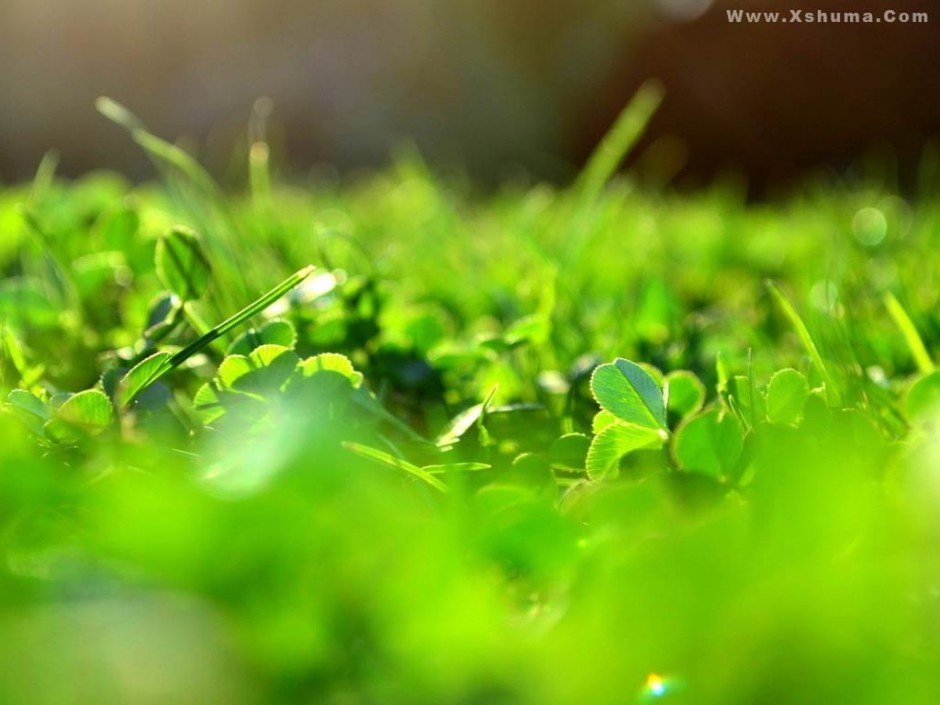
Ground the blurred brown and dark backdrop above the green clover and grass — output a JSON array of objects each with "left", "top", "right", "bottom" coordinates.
[{"left": 0, "top": 0, "right": 940, "bottom": 189}]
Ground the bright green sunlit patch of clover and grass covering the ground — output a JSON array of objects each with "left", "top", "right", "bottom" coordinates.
[{"left": 0, "top": 96, "right": 940, "bottom": 705}]
